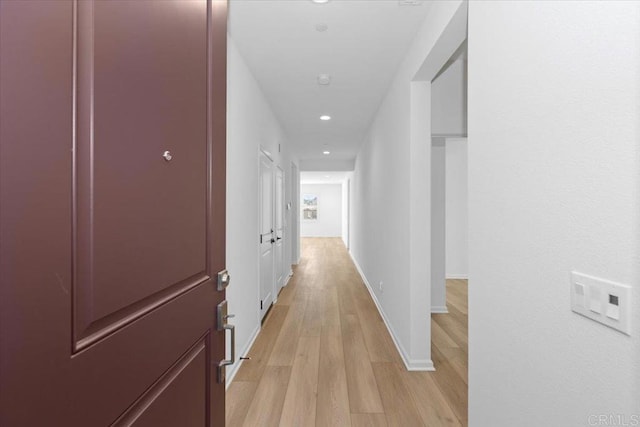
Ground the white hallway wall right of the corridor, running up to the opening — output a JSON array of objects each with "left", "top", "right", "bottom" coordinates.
[{"left": 351, "top": 1, "right": 466, "bottom": 369}]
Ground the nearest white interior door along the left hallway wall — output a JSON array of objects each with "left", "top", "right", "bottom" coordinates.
[{"left": 260, "top": 153, "right": 275, "bottom": 318}]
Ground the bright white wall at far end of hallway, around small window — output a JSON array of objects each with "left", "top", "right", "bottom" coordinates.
[{"left": 300, "top": 184, "right": 342, "bottom": 237}]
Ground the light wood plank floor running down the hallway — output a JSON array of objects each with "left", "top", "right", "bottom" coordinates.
[{"left": 226, "top": 238, "right": 468, "bottom": 427}]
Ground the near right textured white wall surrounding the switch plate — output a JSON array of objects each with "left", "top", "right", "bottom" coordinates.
[{"left": 469, "top": 1, "right": 640, "bottom": 427}]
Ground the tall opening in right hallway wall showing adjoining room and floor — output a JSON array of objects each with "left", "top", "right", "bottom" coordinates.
[{"left": 431, "top": 41, "right": 469, "bottom": 382}]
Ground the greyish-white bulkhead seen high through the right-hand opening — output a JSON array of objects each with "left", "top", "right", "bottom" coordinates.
[{"left": 431, "top": 59, "right": 467, "bottom": 136}]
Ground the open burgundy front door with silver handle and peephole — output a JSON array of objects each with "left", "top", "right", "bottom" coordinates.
[{"left": 0, "top": 0, "right": 227, "bottom": 427}]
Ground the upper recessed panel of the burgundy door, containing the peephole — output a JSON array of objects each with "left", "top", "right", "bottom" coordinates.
[{"left": 74, "top": 1, "right": 212, "bottom": 350}]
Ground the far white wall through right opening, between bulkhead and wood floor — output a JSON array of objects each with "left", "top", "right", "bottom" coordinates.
[{"left": 445, "top": 138, "right": 469, "bottom": 279}]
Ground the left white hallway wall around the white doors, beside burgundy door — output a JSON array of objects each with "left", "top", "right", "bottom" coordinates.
[{"left": 225, "top": 38, "right": 292, "bottom": 382}]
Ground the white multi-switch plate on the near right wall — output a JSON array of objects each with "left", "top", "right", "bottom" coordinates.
[{"left": 571, "top": 271, "right": 631, "bottom": 335}]
